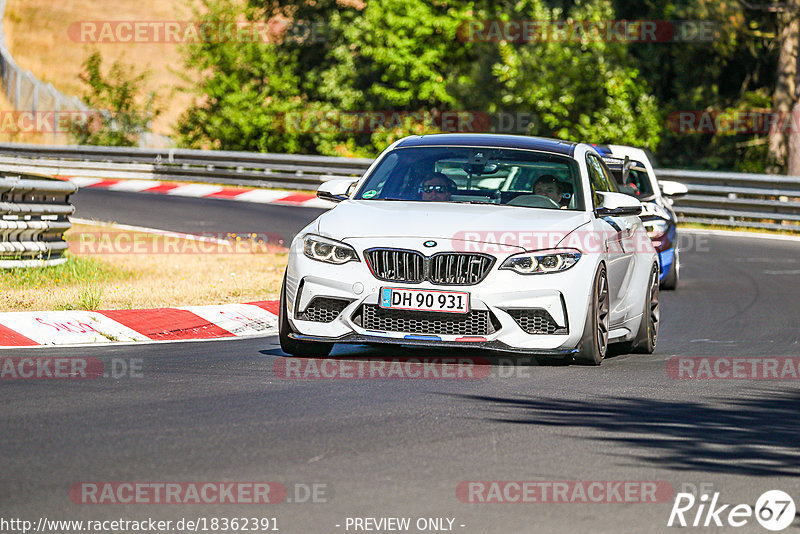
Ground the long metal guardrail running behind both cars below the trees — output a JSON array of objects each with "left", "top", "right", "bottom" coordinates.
[{"left": 0, "top": 143, "right": 800, "bottom": 232}]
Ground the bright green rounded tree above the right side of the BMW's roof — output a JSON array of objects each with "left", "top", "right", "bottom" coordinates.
[{"left": 494, "top": 0, "right": 661, "bottom": 149}]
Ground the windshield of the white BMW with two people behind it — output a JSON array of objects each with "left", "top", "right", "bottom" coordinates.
[{"left": 354, "top": 147, "right": 584, "bottom": 214}]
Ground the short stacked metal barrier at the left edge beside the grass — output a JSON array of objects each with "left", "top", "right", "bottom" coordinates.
[{"left": 0, "top": 175, "right": 77, "bottom": 269}]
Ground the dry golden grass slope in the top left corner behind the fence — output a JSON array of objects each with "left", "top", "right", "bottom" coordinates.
[{"left": 2, "top": 0, "right": 200, "bottom": 143}]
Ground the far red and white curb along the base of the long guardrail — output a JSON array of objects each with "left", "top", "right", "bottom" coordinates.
[{"left": 62, "top": 176, "right": 334, "bottom": 208}]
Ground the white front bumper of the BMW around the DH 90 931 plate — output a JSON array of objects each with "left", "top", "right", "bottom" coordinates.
[{"left": 286, "top": 241, "right": 598, "bottom": 356}]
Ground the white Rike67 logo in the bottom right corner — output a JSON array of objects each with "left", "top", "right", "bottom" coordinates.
[{"left": 667, "top": 490, "right": 795, "bottom": 532}]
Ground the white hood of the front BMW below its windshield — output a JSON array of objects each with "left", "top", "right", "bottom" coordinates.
[{"left": 317, "top": 200, "right": 589, "bottom": 249}]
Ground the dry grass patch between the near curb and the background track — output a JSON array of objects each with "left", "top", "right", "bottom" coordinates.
[{"left": 0, "top": 224, "right": 287, "bottom": 311}]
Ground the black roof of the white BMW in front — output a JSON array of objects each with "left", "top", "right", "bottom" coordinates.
[{"left": 395, "top": 134, "right": 577, "bottom": 156}]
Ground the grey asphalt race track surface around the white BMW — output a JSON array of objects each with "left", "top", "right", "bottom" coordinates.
[{"left": 0, "top": 192, "right": 800, "bottom": 533}]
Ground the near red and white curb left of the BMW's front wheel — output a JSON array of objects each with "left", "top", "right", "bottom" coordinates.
[{"left": 0, "top": 300, "right": 278, "bottom": 348}]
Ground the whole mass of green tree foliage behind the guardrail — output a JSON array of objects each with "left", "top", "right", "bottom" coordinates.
[{"left": 173, "top": 0, "right": 788, "bottom": 170}]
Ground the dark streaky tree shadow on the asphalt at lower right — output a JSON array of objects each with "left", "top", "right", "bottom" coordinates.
[{"left": 456, "top": 391, "right": 800, "bottom": 476}]
